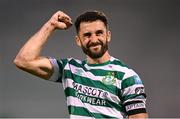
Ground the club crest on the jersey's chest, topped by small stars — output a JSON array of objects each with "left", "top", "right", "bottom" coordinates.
[{"left": 102, "top": 72, "right": 116, "bottom": 85}]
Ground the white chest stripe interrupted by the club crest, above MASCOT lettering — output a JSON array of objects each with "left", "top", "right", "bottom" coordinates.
[{"left": 65, "top": 64, "right": 121, "bottom": 89}]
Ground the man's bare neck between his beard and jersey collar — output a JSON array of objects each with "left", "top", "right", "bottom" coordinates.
[{"left": 87, "top": 51, "right": 111, "bottom": 64}]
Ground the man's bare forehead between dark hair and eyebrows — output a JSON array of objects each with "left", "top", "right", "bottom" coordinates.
[{"left": 79, "top": 20, "right": 106, "bottom": 33}]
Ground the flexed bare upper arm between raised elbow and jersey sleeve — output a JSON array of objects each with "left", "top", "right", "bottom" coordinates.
[{"left": 14, "top": 57, "right": 53, "bottom": 79}]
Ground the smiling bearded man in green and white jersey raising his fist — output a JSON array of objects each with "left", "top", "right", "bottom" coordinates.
[{"left": 14, "top": 11, "right": 147, "bottom": 119}]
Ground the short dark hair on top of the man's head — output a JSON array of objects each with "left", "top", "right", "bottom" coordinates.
[{"left": 75, "top": 10, "right": 108, "bottom": 33}]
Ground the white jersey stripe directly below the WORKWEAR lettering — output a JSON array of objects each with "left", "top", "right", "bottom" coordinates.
[{"left": 67, "top": 96, "right": 123, "bottom": 118}]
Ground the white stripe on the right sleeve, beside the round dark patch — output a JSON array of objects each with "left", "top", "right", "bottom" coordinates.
[{"left": 122, "top": 84, "right": 144, "bottom": 96}]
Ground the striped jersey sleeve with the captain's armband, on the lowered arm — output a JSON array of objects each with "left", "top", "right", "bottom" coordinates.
[{"left": 121, "top": 70, "right": 146, "bottom": 115}]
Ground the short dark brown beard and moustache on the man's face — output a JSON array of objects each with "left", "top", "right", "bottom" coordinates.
[{"left": 81, "top": 40, "right": 108, "bottom": 59}]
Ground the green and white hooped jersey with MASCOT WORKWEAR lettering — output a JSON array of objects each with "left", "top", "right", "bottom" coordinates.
[{"left": 50, "top": 57, "right": 146, "bottom": 119}]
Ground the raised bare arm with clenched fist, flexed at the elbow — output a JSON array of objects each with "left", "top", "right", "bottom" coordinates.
[{"left": 14, "top": 11, "right": 72, "bottom": 79}]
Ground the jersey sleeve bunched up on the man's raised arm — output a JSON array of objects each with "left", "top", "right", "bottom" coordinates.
[{"left": 49, "top": 58, "right": 66, "bottom": 83}]
